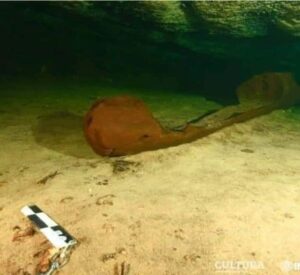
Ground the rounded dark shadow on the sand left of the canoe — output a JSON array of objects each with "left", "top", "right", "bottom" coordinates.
[{"left": 32, "top": 111, "right": 99, "bottom": 159}]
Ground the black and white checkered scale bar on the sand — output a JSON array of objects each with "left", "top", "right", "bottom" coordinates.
[{"left": 21, "top": 205, "right": 76, "bottom": 248}]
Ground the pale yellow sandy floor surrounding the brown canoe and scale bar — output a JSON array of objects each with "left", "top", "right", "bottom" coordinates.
[{"left": 0, "top": 81, "right": 300, "bottom": 275}]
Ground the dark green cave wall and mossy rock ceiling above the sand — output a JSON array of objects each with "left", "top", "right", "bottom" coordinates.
[{"left": 0, "top": 1, "right": 300, "bottom": 102}]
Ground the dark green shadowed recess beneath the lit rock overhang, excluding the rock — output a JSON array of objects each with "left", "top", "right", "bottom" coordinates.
[{"left": 0, "top": 2, "right": 296, "bottom": 103}]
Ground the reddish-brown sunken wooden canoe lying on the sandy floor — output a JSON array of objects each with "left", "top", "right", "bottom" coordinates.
[{"left": 84, "top": 73, "right": 300, "bottom": 156}]
